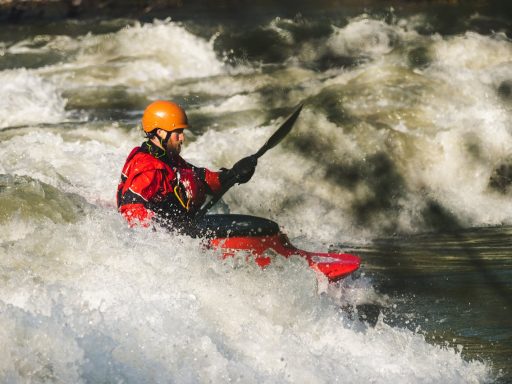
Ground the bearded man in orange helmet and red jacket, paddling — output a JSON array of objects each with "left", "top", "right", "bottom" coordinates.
[{"left": 117, "top": 100, "right": 257, "bottom": 235}]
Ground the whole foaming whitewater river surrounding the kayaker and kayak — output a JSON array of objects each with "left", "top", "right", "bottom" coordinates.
[{"left": 0, "top": 3, "right": 512, "bottom": 383}]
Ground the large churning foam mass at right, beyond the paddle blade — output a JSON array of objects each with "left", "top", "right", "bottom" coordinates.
[{"left": 312, "top": 27, "right": 512, "bottom": 233}]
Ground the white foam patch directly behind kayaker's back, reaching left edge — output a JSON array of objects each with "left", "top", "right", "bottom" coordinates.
[{"left": 0, "top": 128, "right": 138, "bottom": 206}]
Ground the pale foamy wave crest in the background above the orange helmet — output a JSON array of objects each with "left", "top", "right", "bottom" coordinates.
[{"left": 43, "top": 20, "right": 223, "bottom": 90}]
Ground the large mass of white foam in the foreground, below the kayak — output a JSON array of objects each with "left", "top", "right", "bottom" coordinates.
[{"left": 0, "top": 211, "right": 489, "bottom": 383}]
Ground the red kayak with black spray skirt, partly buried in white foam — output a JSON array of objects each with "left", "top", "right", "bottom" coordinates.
[{"left": 198, "top": 214, "right": 361, "bottom": 282}]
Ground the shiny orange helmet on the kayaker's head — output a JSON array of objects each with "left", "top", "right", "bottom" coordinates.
[{"left": 142, "top": 100, "right": 188, "bottom": 133}]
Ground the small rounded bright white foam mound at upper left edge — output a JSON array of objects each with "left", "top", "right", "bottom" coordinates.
[{"left": 0, "top": 69, "right": 66, "bottom": 129}]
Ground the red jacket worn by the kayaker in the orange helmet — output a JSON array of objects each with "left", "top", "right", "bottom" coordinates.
[{"left": 117, "top": 141, "right": 221, "bottom": 227}]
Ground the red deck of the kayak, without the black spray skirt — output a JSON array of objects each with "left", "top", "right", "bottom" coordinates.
[{"left": 210, "top": 232, "right": 361, "bottom": 281}]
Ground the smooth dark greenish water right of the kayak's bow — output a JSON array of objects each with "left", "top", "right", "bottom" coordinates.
[{"left": 360, "top": 227, "right": 512, "bottom": 382}]
